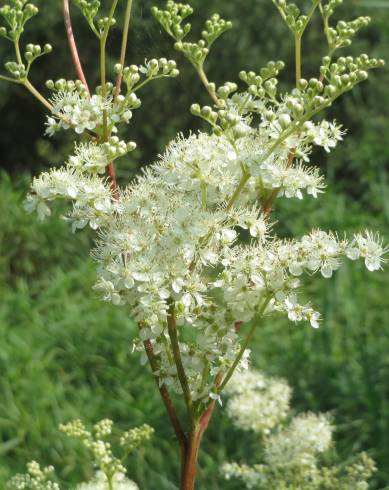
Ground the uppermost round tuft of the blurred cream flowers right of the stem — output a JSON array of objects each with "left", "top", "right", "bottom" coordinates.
[{"left": 225, "top": 370, "right": 291, "bottom": 434}]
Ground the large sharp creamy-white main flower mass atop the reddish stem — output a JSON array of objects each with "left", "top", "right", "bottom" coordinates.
[{"left": 27, "top": 129, "right": 386, "bottom": 400}]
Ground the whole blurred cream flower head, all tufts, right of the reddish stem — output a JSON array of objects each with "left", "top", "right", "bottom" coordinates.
[{"left": 222, "top": 370, "right": 375, "bottom": 490}]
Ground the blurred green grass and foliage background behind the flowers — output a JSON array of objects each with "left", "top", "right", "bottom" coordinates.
[{"left": 0, "top": 0, "right": 389, "bottom": 490}]
